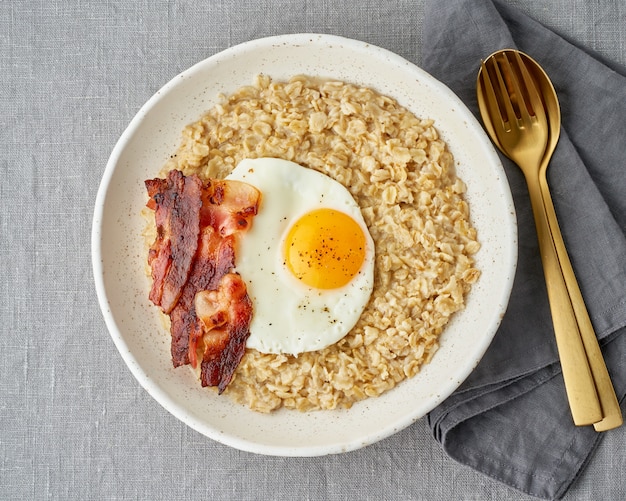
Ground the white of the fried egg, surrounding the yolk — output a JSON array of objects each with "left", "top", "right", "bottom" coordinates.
[{"left": 227, "top": 158, "right": 374, "bottom": 355}]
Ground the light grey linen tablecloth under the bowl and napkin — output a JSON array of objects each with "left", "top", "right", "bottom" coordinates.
[{"left": 0, "top": 0, "right": 626, "bottom": 500}]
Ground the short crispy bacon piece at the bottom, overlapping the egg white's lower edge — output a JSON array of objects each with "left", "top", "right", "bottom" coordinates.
[{"left": 194, "top": 273, "right": 252, "bottom": 393}]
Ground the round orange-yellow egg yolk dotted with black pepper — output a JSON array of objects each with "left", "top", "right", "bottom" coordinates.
[{"left": 285, "top": 209, "right": 366, "bottom": 289}]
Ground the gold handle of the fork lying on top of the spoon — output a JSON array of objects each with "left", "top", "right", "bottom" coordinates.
[{"left": 526, "top": 169, "right": 602, "bottom": 426}]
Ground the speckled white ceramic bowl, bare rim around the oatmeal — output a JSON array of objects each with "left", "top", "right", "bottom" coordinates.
[{"left": 92, "top": 34, "right": 517, "bottom": 456}]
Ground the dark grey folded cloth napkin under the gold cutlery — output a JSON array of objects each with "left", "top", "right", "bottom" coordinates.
[{"left": 422, "top": 0, "right": 626, "bottom": 499}]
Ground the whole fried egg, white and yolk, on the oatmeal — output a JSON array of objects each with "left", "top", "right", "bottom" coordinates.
[{"left": 227, "top": 158, "right": 374, "bottom": 355}]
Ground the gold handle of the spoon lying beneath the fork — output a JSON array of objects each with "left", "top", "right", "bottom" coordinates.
[{"left": 539, "top": 173, "right": 623, "bottom": 431}]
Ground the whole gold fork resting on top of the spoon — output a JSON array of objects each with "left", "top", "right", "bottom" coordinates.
[{"left": 478, "top": 51, "right": 603, "bottom": 426}]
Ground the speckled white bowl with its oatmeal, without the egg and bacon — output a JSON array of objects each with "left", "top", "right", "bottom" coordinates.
[{"left": 92, "top": 34, "right": 517, "bottom": 456}]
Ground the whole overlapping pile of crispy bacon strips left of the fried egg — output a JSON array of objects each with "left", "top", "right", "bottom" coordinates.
[{"left": 145, "top": 171, "right": 260, "bottom": 393}]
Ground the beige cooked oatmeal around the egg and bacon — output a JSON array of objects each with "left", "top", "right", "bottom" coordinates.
[{"left": 147, "top": 75, "right": 479, "bottom": 412}]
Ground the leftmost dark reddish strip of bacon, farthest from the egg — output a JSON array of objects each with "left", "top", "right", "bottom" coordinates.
[{"left": 145, "top": 170, "right": 202, "bottom": 313}]
